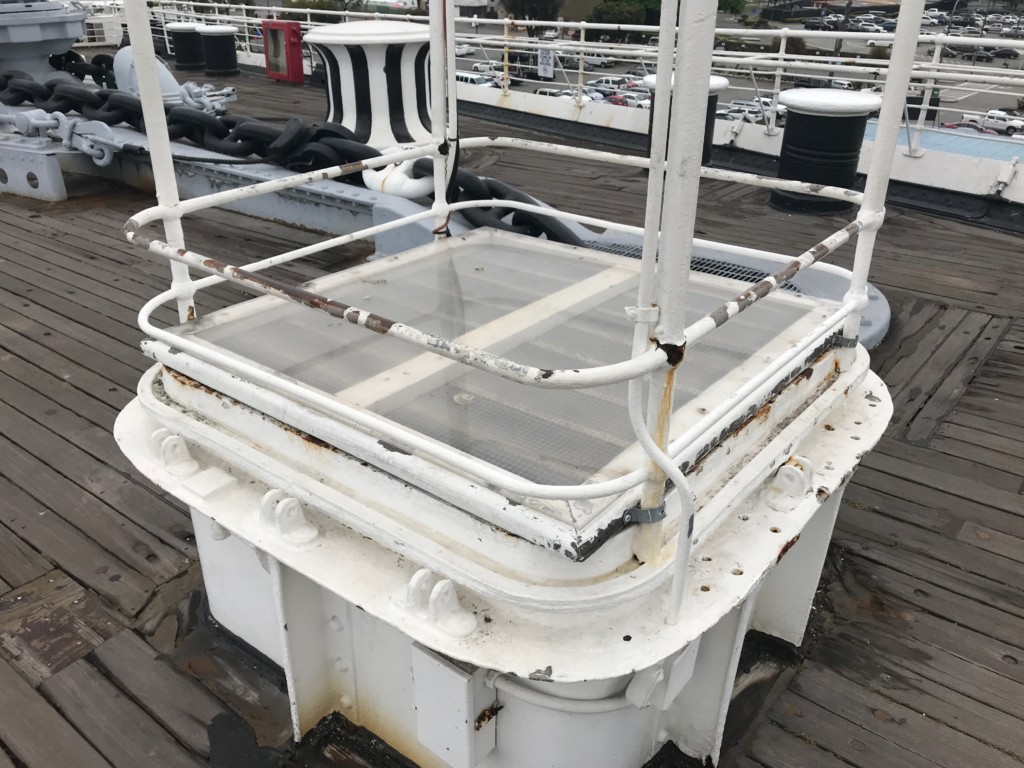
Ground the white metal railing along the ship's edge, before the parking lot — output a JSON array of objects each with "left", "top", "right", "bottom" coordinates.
[{"left": 138, "top": 0, "right": 1024, "bottom": 155}]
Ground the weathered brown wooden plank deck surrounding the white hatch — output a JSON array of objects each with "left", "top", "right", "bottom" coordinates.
[{"left": 0, "top": 69, "right": 1024, "bottom": 768}]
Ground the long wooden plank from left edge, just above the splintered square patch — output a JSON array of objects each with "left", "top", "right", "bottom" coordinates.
[{"left": 0, "top": 477, "right": 156, "bottom": 615}]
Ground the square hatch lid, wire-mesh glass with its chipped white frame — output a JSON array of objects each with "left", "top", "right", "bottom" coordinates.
[{"left": 145, "top": 230, "right": 836, "bottom": 559}]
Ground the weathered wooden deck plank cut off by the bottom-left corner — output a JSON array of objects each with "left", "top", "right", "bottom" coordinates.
[{"left": 0, "top": 660, "right": 111, "bottom": 768}]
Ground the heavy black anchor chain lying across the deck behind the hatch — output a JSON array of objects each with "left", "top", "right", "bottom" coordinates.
[{"left": 0, "top": 66, "right": 583, "bottom": 246}]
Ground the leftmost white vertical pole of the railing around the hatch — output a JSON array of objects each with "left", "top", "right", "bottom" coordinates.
[{"left": 125, "top": 0, "right": 196, "bottom": 323}]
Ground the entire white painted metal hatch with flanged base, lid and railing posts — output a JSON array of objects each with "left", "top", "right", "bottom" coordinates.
[{"left": 116, "top": 0, "right": 923, "bottom": 768}]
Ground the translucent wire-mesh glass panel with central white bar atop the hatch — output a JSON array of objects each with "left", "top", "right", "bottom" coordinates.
[{"left": 182, "top": 233, "right": 835, "bottom": 484}]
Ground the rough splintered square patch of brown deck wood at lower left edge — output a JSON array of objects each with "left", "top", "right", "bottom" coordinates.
[{"left": 0, "top": 570, "right": 122, "bottom": 686}]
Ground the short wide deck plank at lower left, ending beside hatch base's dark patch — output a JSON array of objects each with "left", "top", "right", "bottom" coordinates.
[{"left": 91, "top": 631, "right": 234, "bottom": 757}]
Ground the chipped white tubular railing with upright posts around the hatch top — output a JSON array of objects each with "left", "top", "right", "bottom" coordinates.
[{"left": 126, "top": 0, "right": 924, "bottom": 623}]
